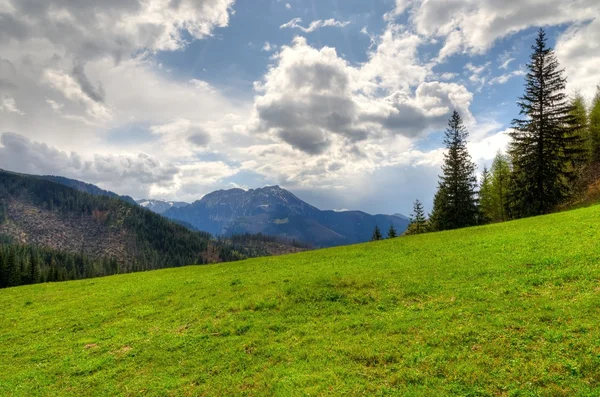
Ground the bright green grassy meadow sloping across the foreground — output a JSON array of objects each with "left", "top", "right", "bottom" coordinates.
[{"left": 0, "top": 206, "right": 600, "bottom": 396}]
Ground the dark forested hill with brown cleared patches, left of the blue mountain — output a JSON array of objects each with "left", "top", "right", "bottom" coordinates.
[{"left": 0, "top": 171, "right": 305, "bottom": 285}]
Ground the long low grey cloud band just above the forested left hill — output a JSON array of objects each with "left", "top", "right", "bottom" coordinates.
[{"left": 0, "top": 133, "right": 237, "bottom": 199}]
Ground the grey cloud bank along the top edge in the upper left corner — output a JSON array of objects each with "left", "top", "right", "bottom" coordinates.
[{"left": 0, "top": 0, "right": 234, "bottom": 60}]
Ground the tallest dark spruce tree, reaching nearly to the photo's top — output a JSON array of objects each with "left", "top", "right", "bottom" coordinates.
[{"left": 510, "top": 29, "right": 579, "bottom": 217}]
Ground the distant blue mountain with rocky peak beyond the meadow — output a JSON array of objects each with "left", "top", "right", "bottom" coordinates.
[{"left": 163, "top": 186, "right": 408, "bottom": 247}]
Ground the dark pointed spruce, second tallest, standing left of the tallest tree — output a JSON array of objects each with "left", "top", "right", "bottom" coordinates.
[{"left": 430, "top": 111, "right": 479, "bottom": 230}]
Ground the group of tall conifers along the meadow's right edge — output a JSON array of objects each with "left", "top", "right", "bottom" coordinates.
[{"left": 372, "top": 29, "right": 600, "bottom": 235}]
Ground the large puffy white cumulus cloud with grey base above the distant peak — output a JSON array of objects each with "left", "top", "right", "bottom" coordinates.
[{"left": 251, "top": 24, "right": 472, "bottom": 155}]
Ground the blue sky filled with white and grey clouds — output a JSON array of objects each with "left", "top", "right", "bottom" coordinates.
[{"left": 0, "top": 0, "right": 600, "bottom": 214}]
